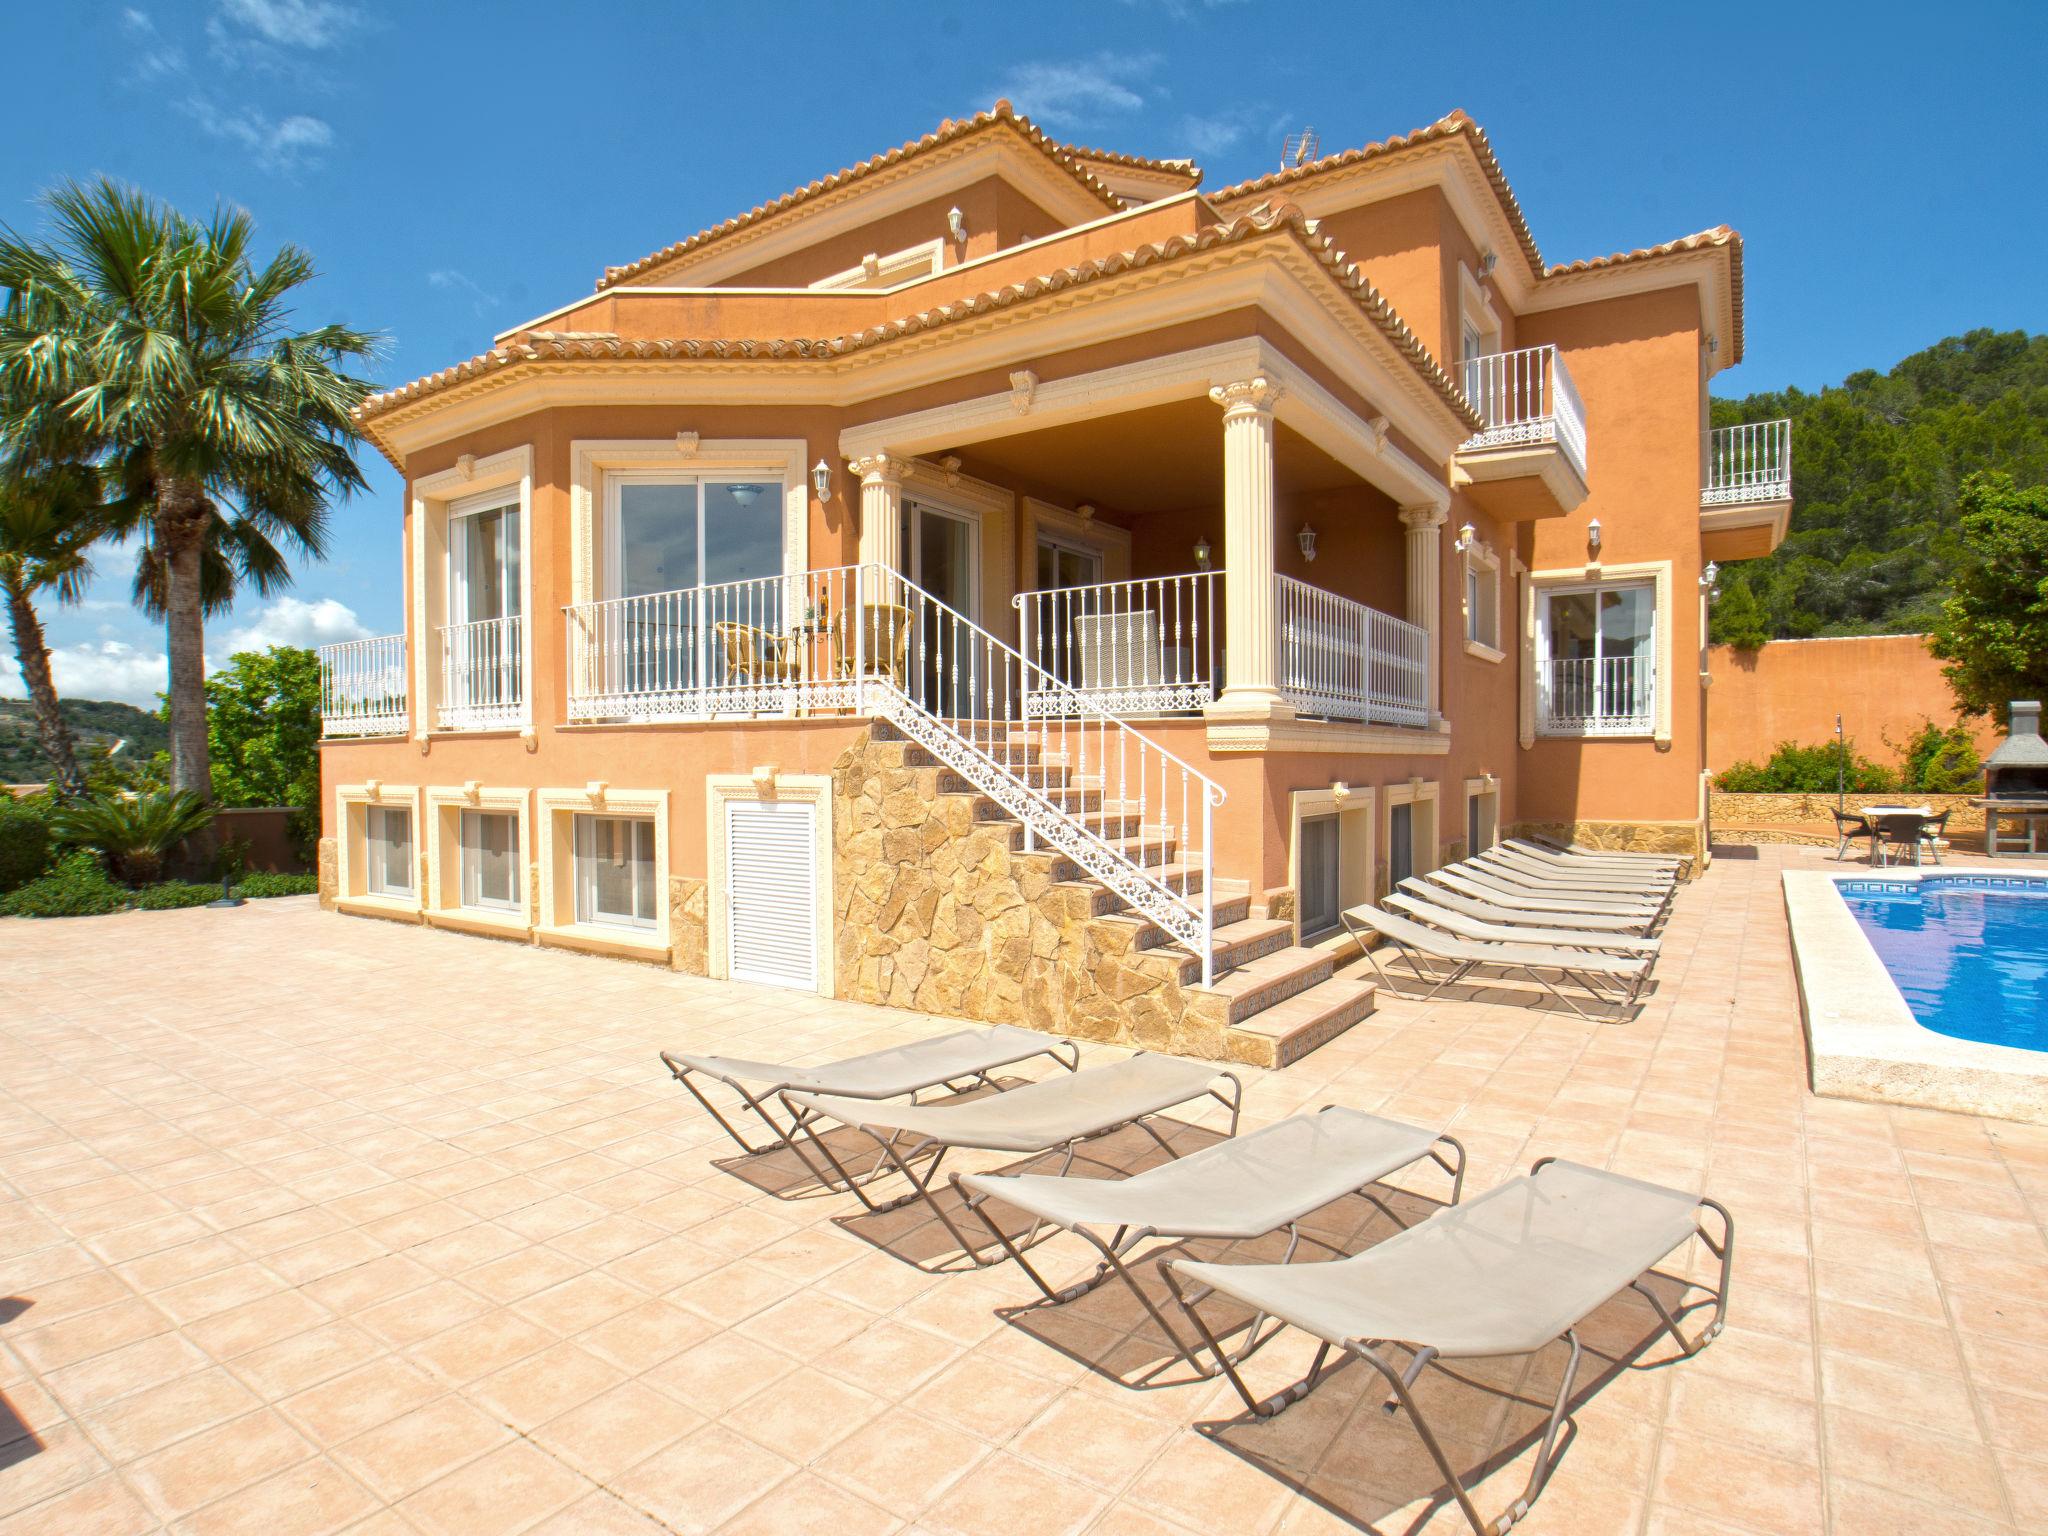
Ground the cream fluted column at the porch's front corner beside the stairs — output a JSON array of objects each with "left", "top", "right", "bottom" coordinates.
[{"left": 1208, "top": 379, "right": 1294, "bottom": 719}]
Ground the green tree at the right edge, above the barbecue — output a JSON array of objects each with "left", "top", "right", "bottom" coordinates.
[{"left": 1927, "top": 475, "right": 2048, "bottom": 715}]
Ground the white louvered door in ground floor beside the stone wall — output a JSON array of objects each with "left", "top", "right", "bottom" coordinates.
[{"left": 725, "top": 801, "right": 817, "bottom": 991}]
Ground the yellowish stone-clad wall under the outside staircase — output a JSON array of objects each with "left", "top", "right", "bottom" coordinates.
[{"left": 831, "top": 733, "right": 1233, "bottom": 1059}]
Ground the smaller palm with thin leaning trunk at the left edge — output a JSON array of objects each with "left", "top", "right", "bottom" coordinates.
[{"left": 0, "top": 461, "right": 106, "bottom": 797}]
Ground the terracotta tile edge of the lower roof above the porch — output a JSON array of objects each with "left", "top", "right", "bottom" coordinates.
[{"left": 356, "top": 205, "right": 1479, "bottom": 428}]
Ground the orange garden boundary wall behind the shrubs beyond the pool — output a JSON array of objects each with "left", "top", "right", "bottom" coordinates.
[{"left": 1706, "top": 635, "right": 2003, "bottom": 772}]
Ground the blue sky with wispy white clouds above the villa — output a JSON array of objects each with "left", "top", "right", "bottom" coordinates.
[{"left": 0, "top": 0, "right": 2048, "bottom": 702}]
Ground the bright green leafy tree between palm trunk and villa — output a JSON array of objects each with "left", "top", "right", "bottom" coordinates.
[{"left": 195, "top": 645, "right": 319, "bottom": 838}]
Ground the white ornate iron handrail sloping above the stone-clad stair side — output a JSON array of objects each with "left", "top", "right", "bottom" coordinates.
[{"left": 854, "top": 565, "right": 1227, "bottom": 985}]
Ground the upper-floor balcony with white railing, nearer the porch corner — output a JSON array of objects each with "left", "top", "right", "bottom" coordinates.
[{"left": 1456, "top": 346, "right": 1587, "bottom": 522}]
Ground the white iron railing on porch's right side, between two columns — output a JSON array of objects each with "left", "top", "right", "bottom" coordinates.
[{"left": 1274, "top": 575, "right": 1430, "bottom": 725}]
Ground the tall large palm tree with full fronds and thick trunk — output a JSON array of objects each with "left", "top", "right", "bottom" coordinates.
[{"left": 0, "top": 178, "right": 377, "bottom": 797}]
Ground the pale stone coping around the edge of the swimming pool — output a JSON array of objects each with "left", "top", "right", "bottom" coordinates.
[{"left": 1784, "top": 864, "right": 2048, "bottom": 1124}]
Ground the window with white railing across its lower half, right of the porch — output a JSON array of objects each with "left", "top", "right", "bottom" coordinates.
[{"left": 1536, "top": 582, "right": 1657, "bottom": 735}]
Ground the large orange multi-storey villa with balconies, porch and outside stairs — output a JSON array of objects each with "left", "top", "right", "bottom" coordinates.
[{"left": 319, "top": 102, "right": 1792, "bottom": 1065}]
